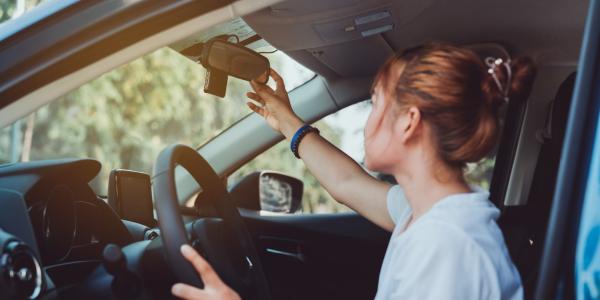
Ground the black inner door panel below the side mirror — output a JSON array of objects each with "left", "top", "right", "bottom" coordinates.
[{"left": 240, "top": 210, "right": 390, "bottom": 299}]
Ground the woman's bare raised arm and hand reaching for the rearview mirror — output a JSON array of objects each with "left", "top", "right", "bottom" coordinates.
[{"left": 247, "top": 70, "right": 394, "bottom": 231}]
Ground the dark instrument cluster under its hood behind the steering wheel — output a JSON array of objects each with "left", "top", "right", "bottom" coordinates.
[{"left": 25, "top": 181, "right": 132, "bottom": 266}]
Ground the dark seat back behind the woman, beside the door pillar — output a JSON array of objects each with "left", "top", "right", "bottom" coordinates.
[{"left": 498, "top": 73, "right": 575, "bottom": 299}]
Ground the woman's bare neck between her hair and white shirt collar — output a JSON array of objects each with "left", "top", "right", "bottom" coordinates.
[{"left": 395, "top": 163, "right": 471, "bottom": 223}]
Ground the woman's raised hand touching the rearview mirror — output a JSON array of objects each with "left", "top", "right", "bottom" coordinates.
[{"left": 246, "top": 69, "right": 304, "bottom": 139}]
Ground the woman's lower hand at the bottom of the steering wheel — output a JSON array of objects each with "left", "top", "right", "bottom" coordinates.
[{"left": 171, "top": 245, "right": 241, "bottom": 300}]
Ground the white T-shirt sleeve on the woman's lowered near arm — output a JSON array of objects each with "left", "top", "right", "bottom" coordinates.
[{"left": 385, "top": 222, "right": 501, "bottom": 300}]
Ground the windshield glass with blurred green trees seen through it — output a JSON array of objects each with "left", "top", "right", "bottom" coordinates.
[{"left": 0, "top": 18, "right": 314, "bottom": 195}]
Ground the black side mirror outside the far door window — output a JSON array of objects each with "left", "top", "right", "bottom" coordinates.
[{"left": 230, "top": 171, "right": 304, "bottom": 214}]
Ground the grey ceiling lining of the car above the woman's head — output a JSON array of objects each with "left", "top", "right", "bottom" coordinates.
[{"left": 244, "top": 0, "right": 588, "bottom": 78}]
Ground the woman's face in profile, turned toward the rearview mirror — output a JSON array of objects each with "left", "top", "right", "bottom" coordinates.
[{"left": 364, "top": 85, "right": 401, "bottom": 174}]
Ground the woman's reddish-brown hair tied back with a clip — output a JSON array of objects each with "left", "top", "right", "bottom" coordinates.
[{"left": 373, "top": 43, "right": 536, "bottom": 166}]
